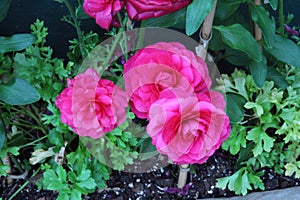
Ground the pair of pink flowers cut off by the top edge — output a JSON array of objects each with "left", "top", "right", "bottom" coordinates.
[{"left": 83, "top": 0, "right": 192, "bottom": 30}]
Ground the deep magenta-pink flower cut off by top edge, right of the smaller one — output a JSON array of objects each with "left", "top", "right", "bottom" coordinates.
[{"left": 126, "top": 0, "right": 192, "bottom": 20}]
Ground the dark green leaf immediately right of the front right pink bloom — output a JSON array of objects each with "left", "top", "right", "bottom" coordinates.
[{"left": 226, "top": 93, "right": 246, "bottom": 123}]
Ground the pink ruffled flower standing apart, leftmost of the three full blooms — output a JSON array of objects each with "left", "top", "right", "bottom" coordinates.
[{"left": 55, "top": 68, "right": 128, "bottom": 138}]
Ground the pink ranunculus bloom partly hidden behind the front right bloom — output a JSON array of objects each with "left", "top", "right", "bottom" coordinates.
[{"left": 124, "top": 42, "right": 211, "bottom": 118}]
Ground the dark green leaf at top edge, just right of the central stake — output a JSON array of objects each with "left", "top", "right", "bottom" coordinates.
[{"left": 215, "top": 0, "right": 241, "bottom": 20}]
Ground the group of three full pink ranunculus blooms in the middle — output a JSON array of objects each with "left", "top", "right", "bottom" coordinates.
[{"left": 56, "top": 42, "right": 230, "bottom": 164}]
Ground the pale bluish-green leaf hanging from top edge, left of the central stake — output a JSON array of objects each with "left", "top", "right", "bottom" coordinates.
[{"left": 186, "top": 0, "right": 215, "bottom": 35}]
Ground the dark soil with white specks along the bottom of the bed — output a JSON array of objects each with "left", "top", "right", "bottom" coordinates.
[{"left": 0, "top": 150, "right": 300, "bottom": 200}]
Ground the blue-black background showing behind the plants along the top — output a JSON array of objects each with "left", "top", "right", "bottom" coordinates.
[{"left": 0, "top": 0, "right": 300, "bottom": 58}]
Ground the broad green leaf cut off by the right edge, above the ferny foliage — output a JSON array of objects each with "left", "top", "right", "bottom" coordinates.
[{"left": 266, "top": 35, "right": 300, "bottom": 67}]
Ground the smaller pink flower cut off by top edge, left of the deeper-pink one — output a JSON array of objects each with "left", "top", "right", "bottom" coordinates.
[{"left": 83, "top": 0, "right": 125, "bottom": 30}]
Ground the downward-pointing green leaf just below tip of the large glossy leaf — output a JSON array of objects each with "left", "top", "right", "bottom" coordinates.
[{"left": 249, "top": 56, "right": 268, "bottom": 88}]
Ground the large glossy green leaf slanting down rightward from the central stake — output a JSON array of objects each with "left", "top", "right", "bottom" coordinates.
[{"left": 214, "top": 24, "right": 262, "bottom": 62}]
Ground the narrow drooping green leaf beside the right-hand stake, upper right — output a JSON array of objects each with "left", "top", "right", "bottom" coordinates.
[{"left": 250, "top": 5, "right": 276, "bottom": 48}]
